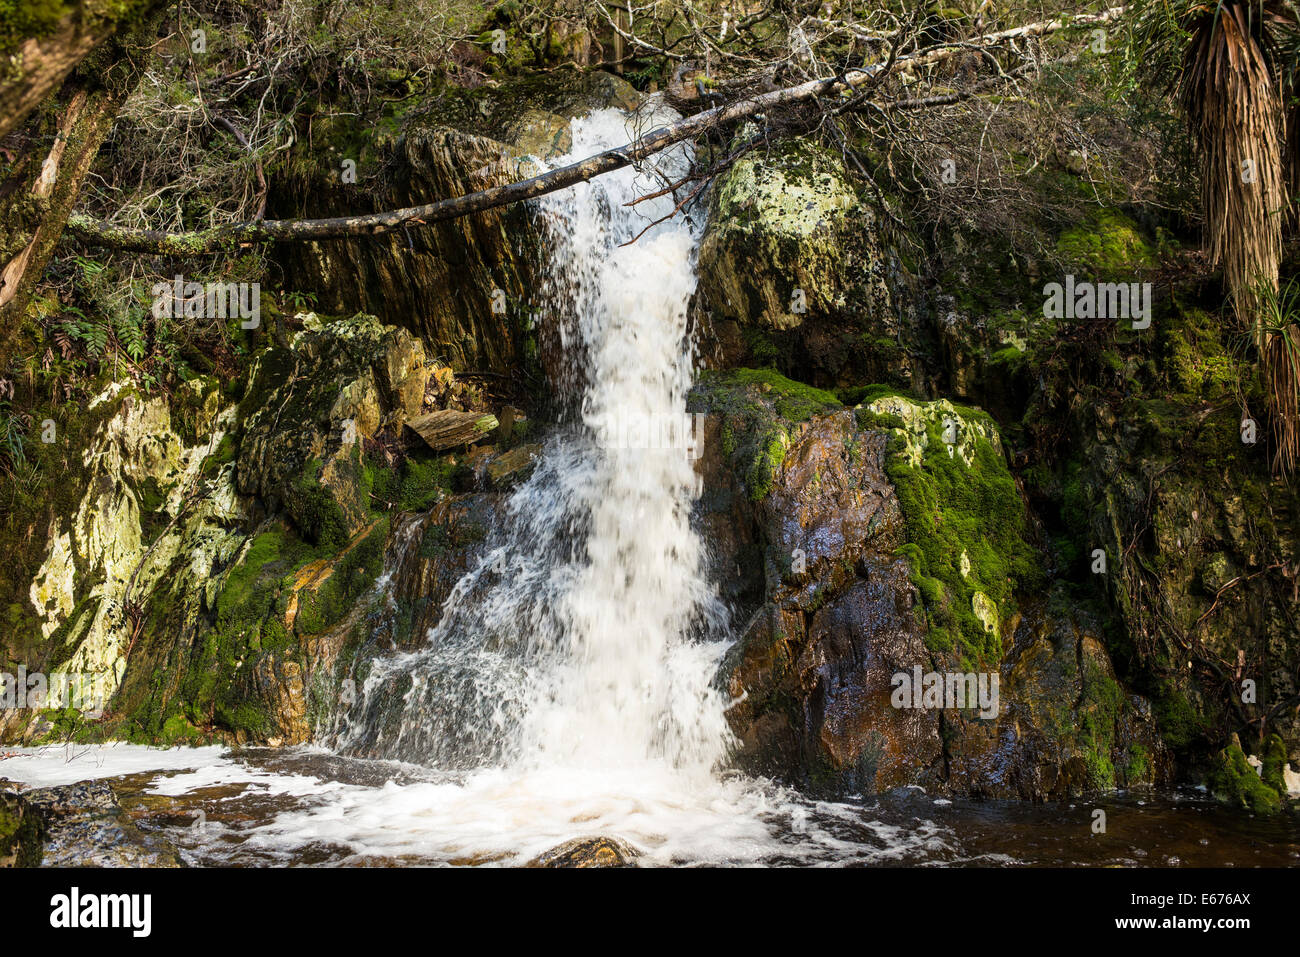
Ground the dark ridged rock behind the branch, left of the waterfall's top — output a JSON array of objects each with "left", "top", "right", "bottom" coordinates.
[{"left": 272, "top": 73, "right": 640, "bottom": 374}]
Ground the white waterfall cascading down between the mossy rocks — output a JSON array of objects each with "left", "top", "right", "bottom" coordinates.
[{"left": 335, "top": 100, "right": 729, "bottom": 776}]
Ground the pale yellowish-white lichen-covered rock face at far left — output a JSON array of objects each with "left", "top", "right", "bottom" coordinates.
[{"left": 9, "top": 380, "right": 243, "bottom": 735}]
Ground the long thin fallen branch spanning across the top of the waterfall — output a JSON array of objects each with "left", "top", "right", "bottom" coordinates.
[{"left": 66, "top": 7, "right": 1126, "bottom": 256}]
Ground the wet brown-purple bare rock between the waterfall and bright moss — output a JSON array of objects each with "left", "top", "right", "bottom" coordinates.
[{"left": 728, "top": 411, "right": 941, "bottom": 793}]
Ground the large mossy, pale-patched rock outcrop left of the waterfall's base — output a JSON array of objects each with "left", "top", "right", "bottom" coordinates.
[{"left": 0, "top": 297, "right": 559, "bottom": 745}]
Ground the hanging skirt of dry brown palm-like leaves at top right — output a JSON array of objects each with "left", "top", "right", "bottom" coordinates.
[{"left": 1135, "top": 0, "right": 1300, "bottom": 473}]
